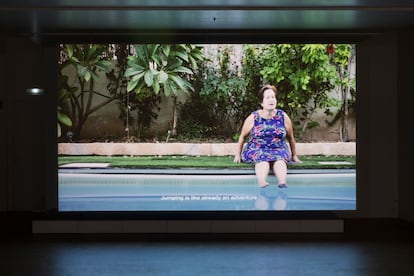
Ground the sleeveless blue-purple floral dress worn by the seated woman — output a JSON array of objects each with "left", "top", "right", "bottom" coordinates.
[{"left": 242, "top": 109, "right": 291, "bottom": 164}]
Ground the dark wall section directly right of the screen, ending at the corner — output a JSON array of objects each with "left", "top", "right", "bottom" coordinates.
[{"left": 356, "top": 33, "right": 398, "bottom": 218}]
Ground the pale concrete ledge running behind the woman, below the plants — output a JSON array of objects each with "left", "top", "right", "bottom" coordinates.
[{"left": 58, "top": 142, "right": 356, "bottom": 156}]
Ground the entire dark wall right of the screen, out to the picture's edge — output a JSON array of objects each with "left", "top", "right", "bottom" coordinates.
[{"left": 357, "top": 25, "right": 414, "bottom": 222}]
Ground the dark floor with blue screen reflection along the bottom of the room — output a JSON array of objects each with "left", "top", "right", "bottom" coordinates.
[{"left": 0, "top": 235, "right": 414, "bottom": 276}]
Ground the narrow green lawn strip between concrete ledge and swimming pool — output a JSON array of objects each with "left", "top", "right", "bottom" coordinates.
[{"left": 58, "top": 155, "right": 356, "bottom": 169}]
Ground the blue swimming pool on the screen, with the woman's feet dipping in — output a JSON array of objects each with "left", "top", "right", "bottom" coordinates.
[{"left": 58, "top": 170, "right": 356, "bottom": 211}]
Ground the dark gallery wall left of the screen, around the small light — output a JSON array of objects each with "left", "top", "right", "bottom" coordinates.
[{"left": 0, "top": 36, "right": 57, "bottom": 212}]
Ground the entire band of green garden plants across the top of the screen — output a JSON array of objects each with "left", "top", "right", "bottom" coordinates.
[{"left": 57, "top": 44, "right": 356, "bottom": 143}]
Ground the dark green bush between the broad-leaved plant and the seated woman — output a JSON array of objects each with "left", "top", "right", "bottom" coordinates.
[{"left": 178, "top": 47, "right": 246, "bottom": 138}]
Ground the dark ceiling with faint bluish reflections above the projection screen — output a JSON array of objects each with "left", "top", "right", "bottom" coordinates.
[{"left": 0, "top": 0, "right": 414, "bottom": 42}]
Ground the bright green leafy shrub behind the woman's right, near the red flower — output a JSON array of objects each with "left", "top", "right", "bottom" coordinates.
[{"left": 259, "top": 44, "right": 348, "bottom": 137}]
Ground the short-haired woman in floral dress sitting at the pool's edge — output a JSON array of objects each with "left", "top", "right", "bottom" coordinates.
[{"left": 234, "top": 85, "right": 301, "bottom": 188}]
